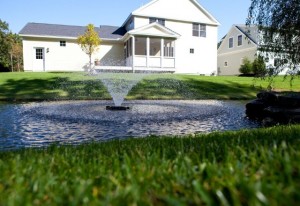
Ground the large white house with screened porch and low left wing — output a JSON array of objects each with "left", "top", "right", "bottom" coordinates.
[{"left": 20, "top": 0, "right": 219, "bottom": 75}]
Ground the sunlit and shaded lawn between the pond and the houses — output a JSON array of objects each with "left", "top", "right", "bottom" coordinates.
[{"left": 0, "top": 73, "right": 300, "bottom": 101}]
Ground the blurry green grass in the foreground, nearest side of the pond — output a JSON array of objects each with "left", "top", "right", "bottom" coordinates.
[{"left": 0, "top": 126, "right": 300, "bottom": 205}]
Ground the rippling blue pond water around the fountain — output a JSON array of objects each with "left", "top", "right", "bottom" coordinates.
[{"left": 0, "top": 100, "right": 259, "bottom": 150}]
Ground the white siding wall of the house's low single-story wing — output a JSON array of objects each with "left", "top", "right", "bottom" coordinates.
[{"left": 23, "top": 38, "right": 124, "bottom": 71}]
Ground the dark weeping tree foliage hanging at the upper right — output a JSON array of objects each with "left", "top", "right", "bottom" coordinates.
[{"left": 246, "top": 0, "right": 300, "bottom": 76}]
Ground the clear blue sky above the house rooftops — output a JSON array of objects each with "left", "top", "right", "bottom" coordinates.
[{"left": 0, "top": 0, "right": 251, "bottom": 39}]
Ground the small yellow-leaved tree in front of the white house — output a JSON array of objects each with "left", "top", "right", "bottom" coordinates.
[{"left": 77, "top": 24, "right": 101, "bottom": 71}]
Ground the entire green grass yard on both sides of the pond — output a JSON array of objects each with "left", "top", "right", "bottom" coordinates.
[{"left": 0, "top": 73, "right": 300, "bottom": 206}]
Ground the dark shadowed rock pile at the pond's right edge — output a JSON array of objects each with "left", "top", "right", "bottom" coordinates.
[{"left": 246, "top": 92, "right": 300, "bottom": 126}]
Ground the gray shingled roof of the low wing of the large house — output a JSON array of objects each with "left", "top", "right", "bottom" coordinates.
[{"left": 19, "top": 23, "right": 126, "bottom": 39}]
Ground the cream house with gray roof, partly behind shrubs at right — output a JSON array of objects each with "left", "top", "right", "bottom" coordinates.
[{"left": 218, "top": 24, "right": 286, "bottom": 75}]
